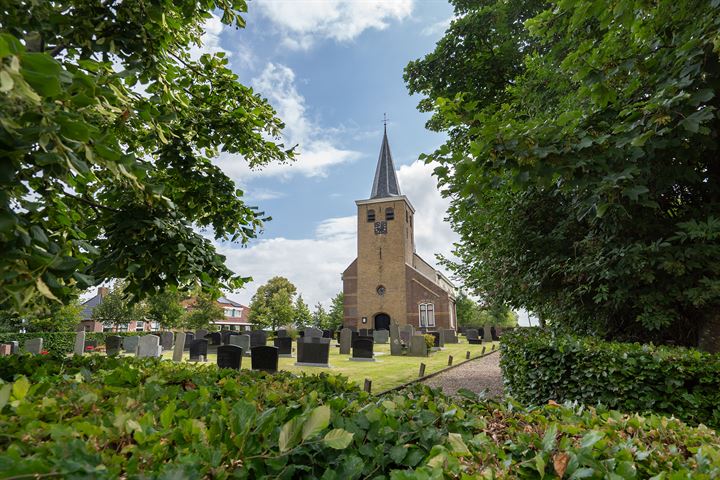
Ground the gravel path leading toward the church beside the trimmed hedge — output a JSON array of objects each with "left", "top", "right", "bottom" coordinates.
[{"left": 425, "top": 352, "right": 503, "bottom": 398}]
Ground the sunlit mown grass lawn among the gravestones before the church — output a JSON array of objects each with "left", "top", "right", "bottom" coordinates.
[{"left": 155, "top": 338, "right": 499, "bottom": 393}]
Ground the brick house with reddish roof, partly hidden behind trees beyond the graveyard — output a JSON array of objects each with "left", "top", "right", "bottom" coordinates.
[{"left": 77, "top": 287, "right": 252, "bottom": 332}]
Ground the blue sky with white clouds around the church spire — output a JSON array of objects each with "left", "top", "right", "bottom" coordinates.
[{"left": 194, "top": 0, "right": 466, "bottom": 307}]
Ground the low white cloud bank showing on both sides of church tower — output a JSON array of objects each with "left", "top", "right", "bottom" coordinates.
[{"left": 218, "top": 161, "right": 458, "bottom": 306}]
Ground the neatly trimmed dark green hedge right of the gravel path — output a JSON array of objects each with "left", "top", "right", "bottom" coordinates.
[{"left": 500, "top": 328, "right": 720, "bottom": 428}]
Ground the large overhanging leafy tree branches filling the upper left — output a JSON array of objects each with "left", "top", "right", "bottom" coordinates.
[{"left": 0, "top": 0, "right": 294, "bottom": 312}]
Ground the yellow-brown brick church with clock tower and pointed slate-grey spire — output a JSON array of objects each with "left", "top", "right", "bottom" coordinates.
[{"left": 342, "top": 127, "right": 457, "bottom": 331}]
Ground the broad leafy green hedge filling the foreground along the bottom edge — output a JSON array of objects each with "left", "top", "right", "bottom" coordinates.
[{"left": 0, "top": 355, "right": 720, "bottom": 480}]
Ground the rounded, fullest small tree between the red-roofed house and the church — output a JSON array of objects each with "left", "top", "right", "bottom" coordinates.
[{"left": 248, "top": 277, "right": 297, "bottom": 330}]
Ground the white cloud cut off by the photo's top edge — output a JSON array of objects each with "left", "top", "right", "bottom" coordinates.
[{"left": 257, "top": 0, "right": 414, "bottom": 50}]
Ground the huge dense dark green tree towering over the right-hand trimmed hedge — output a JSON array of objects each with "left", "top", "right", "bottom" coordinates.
[{"left": 405, "top": 0, "right": 720, "bottom": 345}]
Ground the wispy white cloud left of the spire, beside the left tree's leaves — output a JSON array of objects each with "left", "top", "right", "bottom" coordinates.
[{"left": 216, "top": 63, "right": 361, "bottom": 181}]
